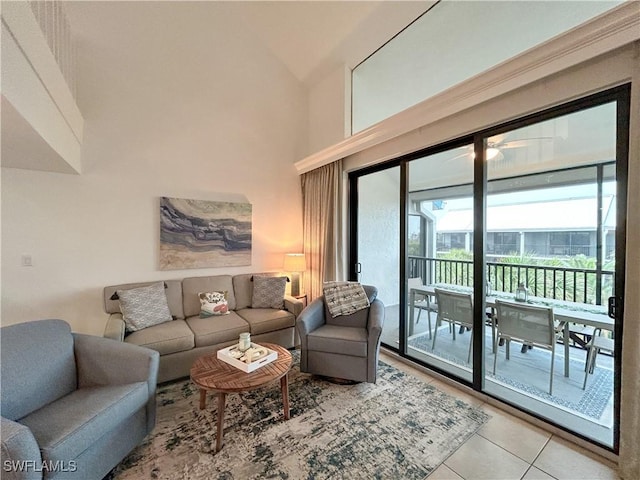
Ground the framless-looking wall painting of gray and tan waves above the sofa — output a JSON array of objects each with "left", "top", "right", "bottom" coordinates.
[{"left": 160, "top": 197, "right": 251, "bottom": 270}]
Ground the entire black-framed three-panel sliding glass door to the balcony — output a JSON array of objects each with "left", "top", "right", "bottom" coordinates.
[{"left": 350, "top": 87, "right": 629, "bottom": 451}]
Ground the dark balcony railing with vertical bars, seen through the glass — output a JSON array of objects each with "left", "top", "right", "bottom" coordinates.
[{"left": 408, "top": 256, "right": 615, "bottom": 305}]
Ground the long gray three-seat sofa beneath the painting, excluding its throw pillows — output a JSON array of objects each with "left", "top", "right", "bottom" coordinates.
[{"left": 104, "top": 273, "right": 304, "bottom": 383}]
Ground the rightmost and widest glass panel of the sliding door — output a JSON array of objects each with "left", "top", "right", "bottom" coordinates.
[{"left": 485, "top": 101, "right": 619, "bottom": 447}]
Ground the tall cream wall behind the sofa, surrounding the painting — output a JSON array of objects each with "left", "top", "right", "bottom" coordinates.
[{"left": 1, "top": 2, "right": 307, "bottom": 334}]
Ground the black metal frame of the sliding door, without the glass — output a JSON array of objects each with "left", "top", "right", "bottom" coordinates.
[{"left": 347, "top": 83, "right": 631, "bottom": 454}]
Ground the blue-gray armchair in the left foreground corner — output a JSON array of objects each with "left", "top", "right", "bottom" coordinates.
[{"left": 1, "top": 320, "right": 159, "bottom": 480}]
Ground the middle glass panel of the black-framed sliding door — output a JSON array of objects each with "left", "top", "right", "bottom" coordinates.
[{"left": 405, "top": 144, "right": 474, "bottom": 382}]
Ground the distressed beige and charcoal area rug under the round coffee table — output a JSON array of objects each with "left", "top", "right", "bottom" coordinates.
[{"left": 111, "top": 352, "right": 489, "bottom": 480}]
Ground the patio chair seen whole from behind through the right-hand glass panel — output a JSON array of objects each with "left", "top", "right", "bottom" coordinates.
[{"left": 493, "top": 299, "right": 556, "bottom": 395}]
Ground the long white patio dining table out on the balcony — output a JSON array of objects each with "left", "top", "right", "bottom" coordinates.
[{"left": 409, "top": 284, "right": 614, "bottom": 377}]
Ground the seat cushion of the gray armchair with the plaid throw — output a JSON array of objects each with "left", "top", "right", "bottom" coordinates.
[{"left": 307, "top": 325, "right": 367, "bottom": 357}]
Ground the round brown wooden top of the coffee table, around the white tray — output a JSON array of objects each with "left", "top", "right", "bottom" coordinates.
[{"left": 191, "top": 343, "right": 293, "bottom": 393}]
